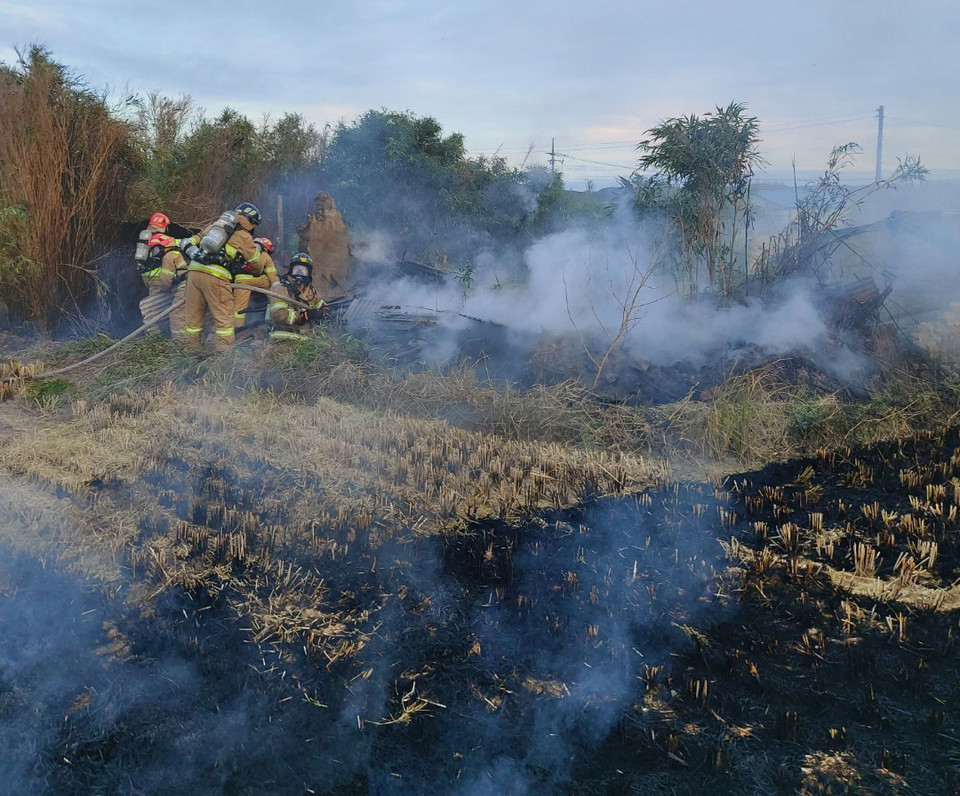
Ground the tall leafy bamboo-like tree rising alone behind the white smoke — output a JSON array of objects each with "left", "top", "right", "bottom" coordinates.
[{"left": 633, "top": 103, "right": 764, "bottom": 295}]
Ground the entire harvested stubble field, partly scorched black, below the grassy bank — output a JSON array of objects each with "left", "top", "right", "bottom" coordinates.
[{"left": 0, "top": 382, "right": 960, "bottom": 794}]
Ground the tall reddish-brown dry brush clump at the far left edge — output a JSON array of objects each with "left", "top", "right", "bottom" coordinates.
[{"left": 0, "top": 46, "right": 135, "bottom": 325}]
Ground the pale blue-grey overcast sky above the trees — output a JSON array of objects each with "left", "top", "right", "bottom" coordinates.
[{"left": 0, "top": 0, "right": 960, "bottom": 187}]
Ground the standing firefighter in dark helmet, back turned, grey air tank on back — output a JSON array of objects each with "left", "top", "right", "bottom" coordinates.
[{"left": 181, "top": 202, "right": 263, "bottom": 351}]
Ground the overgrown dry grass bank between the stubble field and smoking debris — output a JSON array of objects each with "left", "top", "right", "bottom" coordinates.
[{"left": 3, "top": 326, "right": 960, "bottom": 488}]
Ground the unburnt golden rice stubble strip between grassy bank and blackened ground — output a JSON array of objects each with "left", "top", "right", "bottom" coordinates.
[{"left": 0, "top": 385, "right": 664, "bottom": 576}]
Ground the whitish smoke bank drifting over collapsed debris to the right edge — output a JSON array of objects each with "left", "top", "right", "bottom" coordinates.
[{"left": 350, "top": 181, "right": 960, "bottom": 392}]
